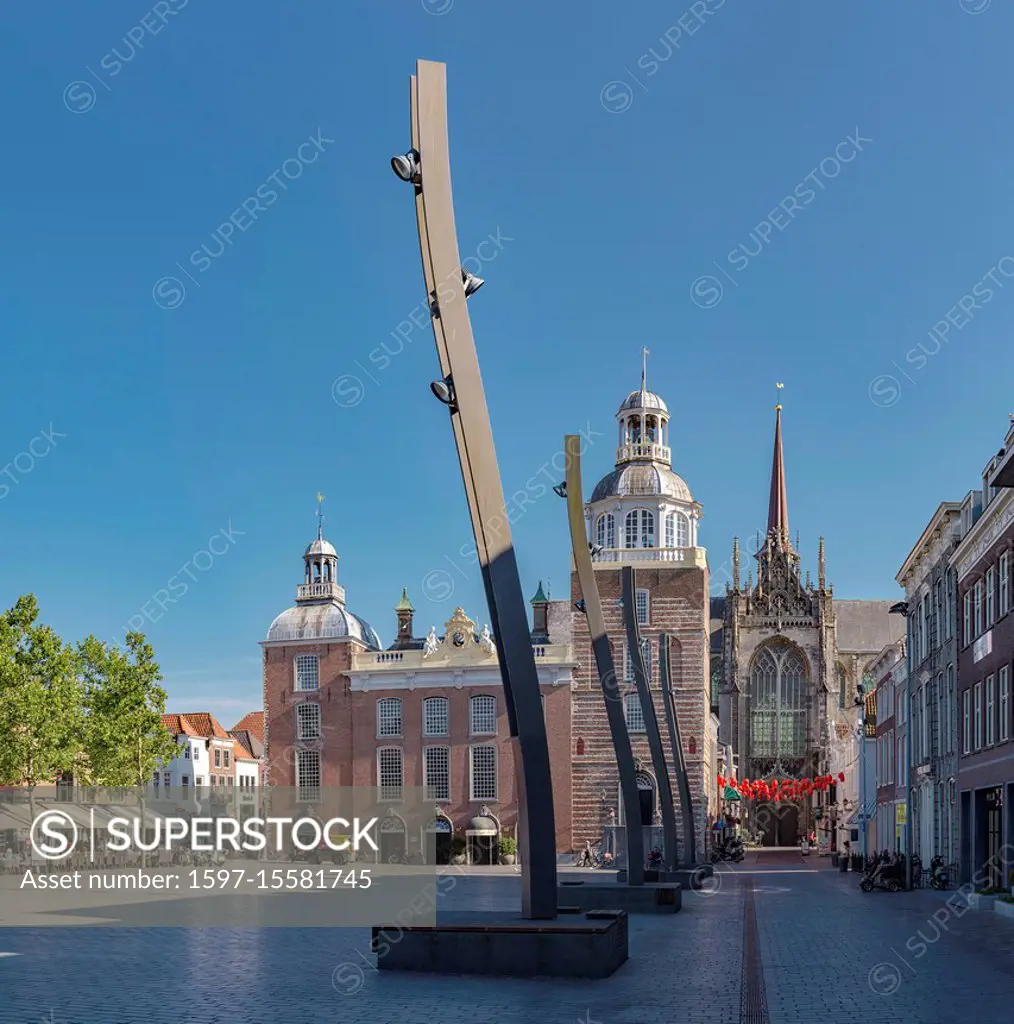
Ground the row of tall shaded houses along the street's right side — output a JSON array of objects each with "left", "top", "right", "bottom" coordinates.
[{"left": 864, "top": 417, "right": 1014, "bottom": 887}]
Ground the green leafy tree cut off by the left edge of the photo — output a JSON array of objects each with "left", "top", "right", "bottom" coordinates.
[{"left": 0, "top": 594, "right": 83, "bottom": 820}]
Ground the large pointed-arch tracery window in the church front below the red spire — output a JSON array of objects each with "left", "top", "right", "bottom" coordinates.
[{"left": 750, "top": 643, "right": 807, "bottom": 757}]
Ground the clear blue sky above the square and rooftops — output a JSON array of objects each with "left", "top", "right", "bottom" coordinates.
[{"left": 0, "top": 0, "right": 1014, "bottom": 726}]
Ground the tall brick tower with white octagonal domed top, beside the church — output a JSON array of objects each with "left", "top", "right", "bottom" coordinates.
[{"left": 572, "top": 352, "right": 717, "bottom": 860}]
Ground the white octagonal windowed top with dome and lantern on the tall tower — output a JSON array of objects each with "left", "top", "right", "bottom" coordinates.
[{"left": 586, "top": 358, "right": 705, "bottom": 567}]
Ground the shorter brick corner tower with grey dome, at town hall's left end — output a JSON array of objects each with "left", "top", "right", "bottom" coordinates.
[{"left": 261, "top": 496, "right": 381, "bottom": 790}]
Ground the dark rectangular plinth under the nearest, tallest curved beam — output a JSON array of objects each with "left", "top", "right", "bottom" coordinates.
[{"left": 372, "top": 909, "right": 628, "bottom": 978}]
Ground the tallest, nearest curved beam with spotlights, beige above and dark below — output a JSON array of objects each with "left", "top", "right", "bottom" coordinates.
[{"left": 405, "top": 60, "right": 557, "bottom": 921}]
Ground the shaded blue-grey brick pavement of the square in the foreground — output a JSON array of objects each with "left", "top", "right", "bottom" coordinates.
[{"left": 0, "top": 854, "right": 1014, "bottom": 1024}]
